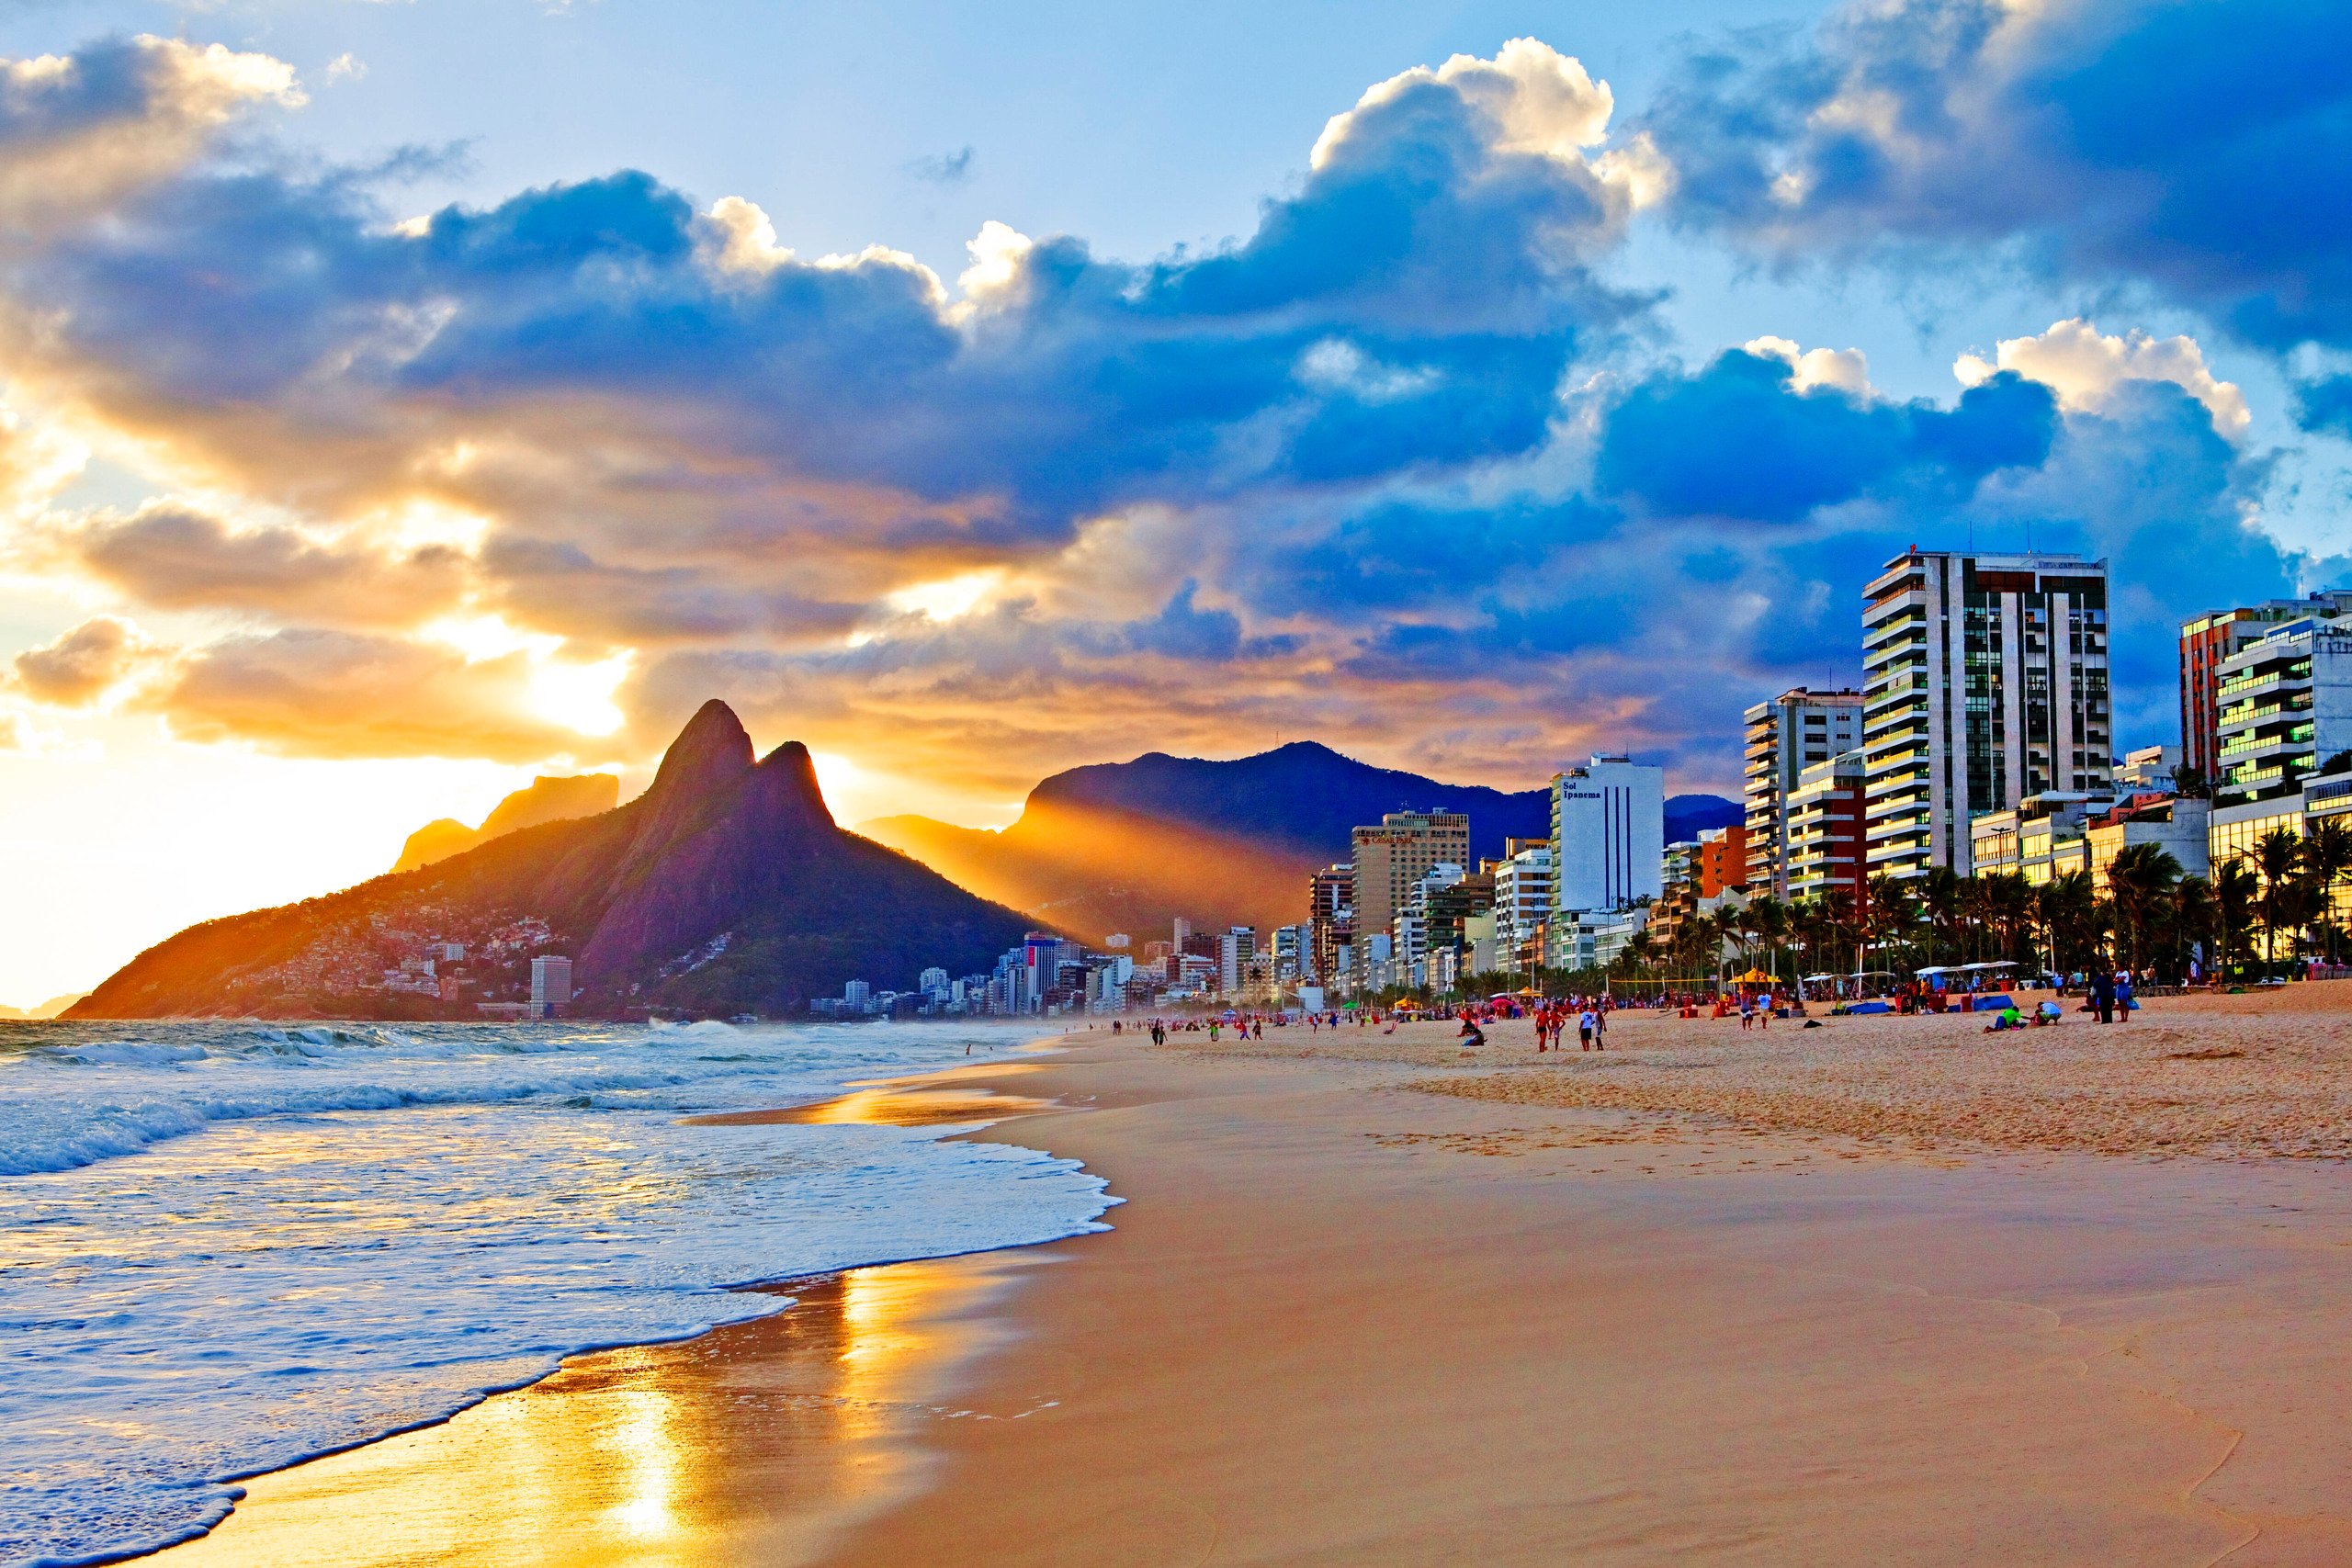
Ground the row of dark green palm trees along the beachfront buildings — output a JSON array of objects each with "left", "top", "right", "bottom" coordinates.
[{"left": 1616, "top": 823, "right": 2352, "bottom": 980}]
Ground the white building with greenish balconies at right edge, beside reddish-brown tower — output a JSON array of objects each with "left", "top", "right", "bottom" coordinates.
[{"left": 2213, "top": 616, "right": 2352, "bottom": 804}]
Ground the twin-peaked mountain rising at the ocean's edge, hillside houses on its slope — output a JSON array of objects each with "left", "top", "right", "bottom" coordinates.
[{"left": 68, "top": 701, "right": 1030, "bottom": 1018}]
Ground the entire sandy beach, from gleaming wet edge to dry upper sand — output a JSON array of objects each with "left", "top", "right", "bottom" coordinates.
[{"left": 141, "top": 985, "right": 2352, "bottom": 1568}]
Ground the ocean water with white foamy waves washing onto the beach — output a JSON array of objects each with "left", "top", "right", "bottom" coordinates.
[{"left": 0, "top": 1022, "right": 1117, "bottom": 1565}]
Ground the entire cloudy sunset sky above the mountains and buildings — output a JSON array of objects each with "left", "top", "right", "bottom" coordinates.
[{"left": 0, "top": 0, "right": 2352, "bottom": 1006}]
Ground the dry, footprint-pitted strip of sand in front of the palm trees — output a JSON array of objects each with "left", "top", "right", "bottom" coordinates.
[{"left": 1176, "top": 980, "right": 2352, "bottom": 1161}]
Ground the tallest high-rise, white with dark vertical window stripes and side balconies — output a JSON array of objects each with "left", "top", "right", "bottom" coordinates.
[{"left": 1863, "top": 550, "right": 2114, "bottom": 877}]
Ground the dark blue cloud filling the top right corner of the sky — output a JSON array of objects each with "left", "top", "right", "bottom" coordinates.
[{"left": 1644, "top": 0, "right": 2352, "bottom": 364}]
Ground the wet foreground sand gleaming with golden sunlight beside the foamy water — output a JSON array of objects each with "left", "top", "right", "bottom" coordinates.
[{"left": 148, "top": 1253, "right": 1040, "bottom": 1568}]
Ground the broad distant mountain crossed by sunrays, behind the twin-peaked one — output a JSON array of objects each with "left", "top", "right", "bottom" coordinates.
[{"left": 861, "top": 740, "right": 1738, "bottom": 938}]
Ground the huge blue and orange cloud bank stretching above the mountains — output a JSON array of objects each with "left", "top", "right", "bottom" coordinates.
[{"left": 0, "top": 24, "right": 2293, "bottom": 799}]
